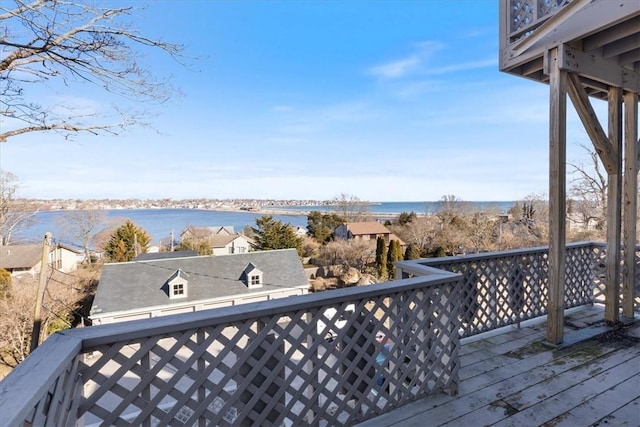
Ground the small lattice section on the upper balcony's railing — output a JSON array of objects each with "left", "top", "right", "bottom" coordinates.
[{"left": 507, "top": 0, "right": 571, "bottom": 42}]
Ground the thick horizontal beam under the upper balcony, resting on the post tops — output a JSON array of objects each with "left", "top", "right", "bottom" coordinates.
[{"left": 560, "top": 44, "right": 640, "bottom": 93}]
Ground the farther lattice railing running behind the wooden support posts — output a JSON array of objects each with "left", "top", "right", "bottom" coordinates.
[{"left": 396, "top": 242, "right": 640, "bottom": 337}]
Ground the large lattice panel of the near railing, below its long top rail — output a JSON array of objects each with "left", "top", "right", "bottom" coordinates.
[{"left": 77, "top": 283, "right": 460, "bottom": 426}]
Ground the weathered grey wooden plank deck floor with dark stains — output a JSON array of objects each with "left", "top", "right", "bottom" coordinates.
[{"left": 359, "top": 307, "right": 640, "bottom": 427}]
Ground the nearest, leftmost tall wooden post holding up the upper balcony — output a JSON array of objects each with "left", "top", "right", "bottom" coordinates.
[{"left": 547, "top": 48, "right": 567, "bottom": 344}]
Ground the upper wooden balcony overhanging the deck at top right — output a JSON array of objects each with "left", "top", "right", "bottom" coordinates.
[{"left": 500, "top": 0, "right": 640, "bottom": 99}]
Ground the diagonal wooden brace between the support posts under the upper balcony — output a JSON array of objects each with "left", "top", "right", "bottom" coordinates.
[{"left": 567, "top": 73, "right": 619, "bottom": 174}]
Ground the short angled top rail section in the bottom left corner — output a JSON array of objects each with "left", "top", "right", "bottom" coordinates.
[{"left": 0, "top": 334, "right": 82, "bottom": 426}]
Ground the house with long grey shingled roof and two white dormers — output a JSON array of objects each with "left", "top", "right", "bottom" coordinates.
[{"left": 90, "top": 249, "right": 309, "bottom": 325}]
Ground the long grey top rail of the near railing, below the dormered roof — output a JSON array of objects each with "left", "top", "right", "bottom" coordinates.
[{"left": 58, "top": 267, "right": 459, "bottom": 351}]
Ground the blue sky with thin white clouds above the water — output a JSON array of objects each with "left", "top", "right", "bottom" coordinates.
[{"left": 0, "top": 0, "right": 603, "bottom": 201}]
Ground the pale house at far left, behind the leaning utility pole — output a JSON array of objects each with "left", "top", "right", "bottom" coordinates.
[{"left": 0, "top": 243, "right": 81, "bottom": 277}]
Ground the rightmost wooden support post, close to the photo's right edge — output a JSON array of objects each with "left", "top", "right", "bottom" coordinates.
[{"left": 622, "top": 92, "right": 640, "bottom": 319}]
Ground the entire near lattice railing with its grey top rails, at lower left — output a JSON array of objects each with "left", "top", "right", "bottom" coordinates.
[{"left": 0, "top": 267, "right": 461, "bottom": 426}]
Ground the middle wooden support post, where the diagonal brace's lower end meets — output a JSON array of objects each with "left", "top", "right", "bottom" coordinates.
[{"left": 604, "top": 87, "right": 622, "bottom": 323}]
